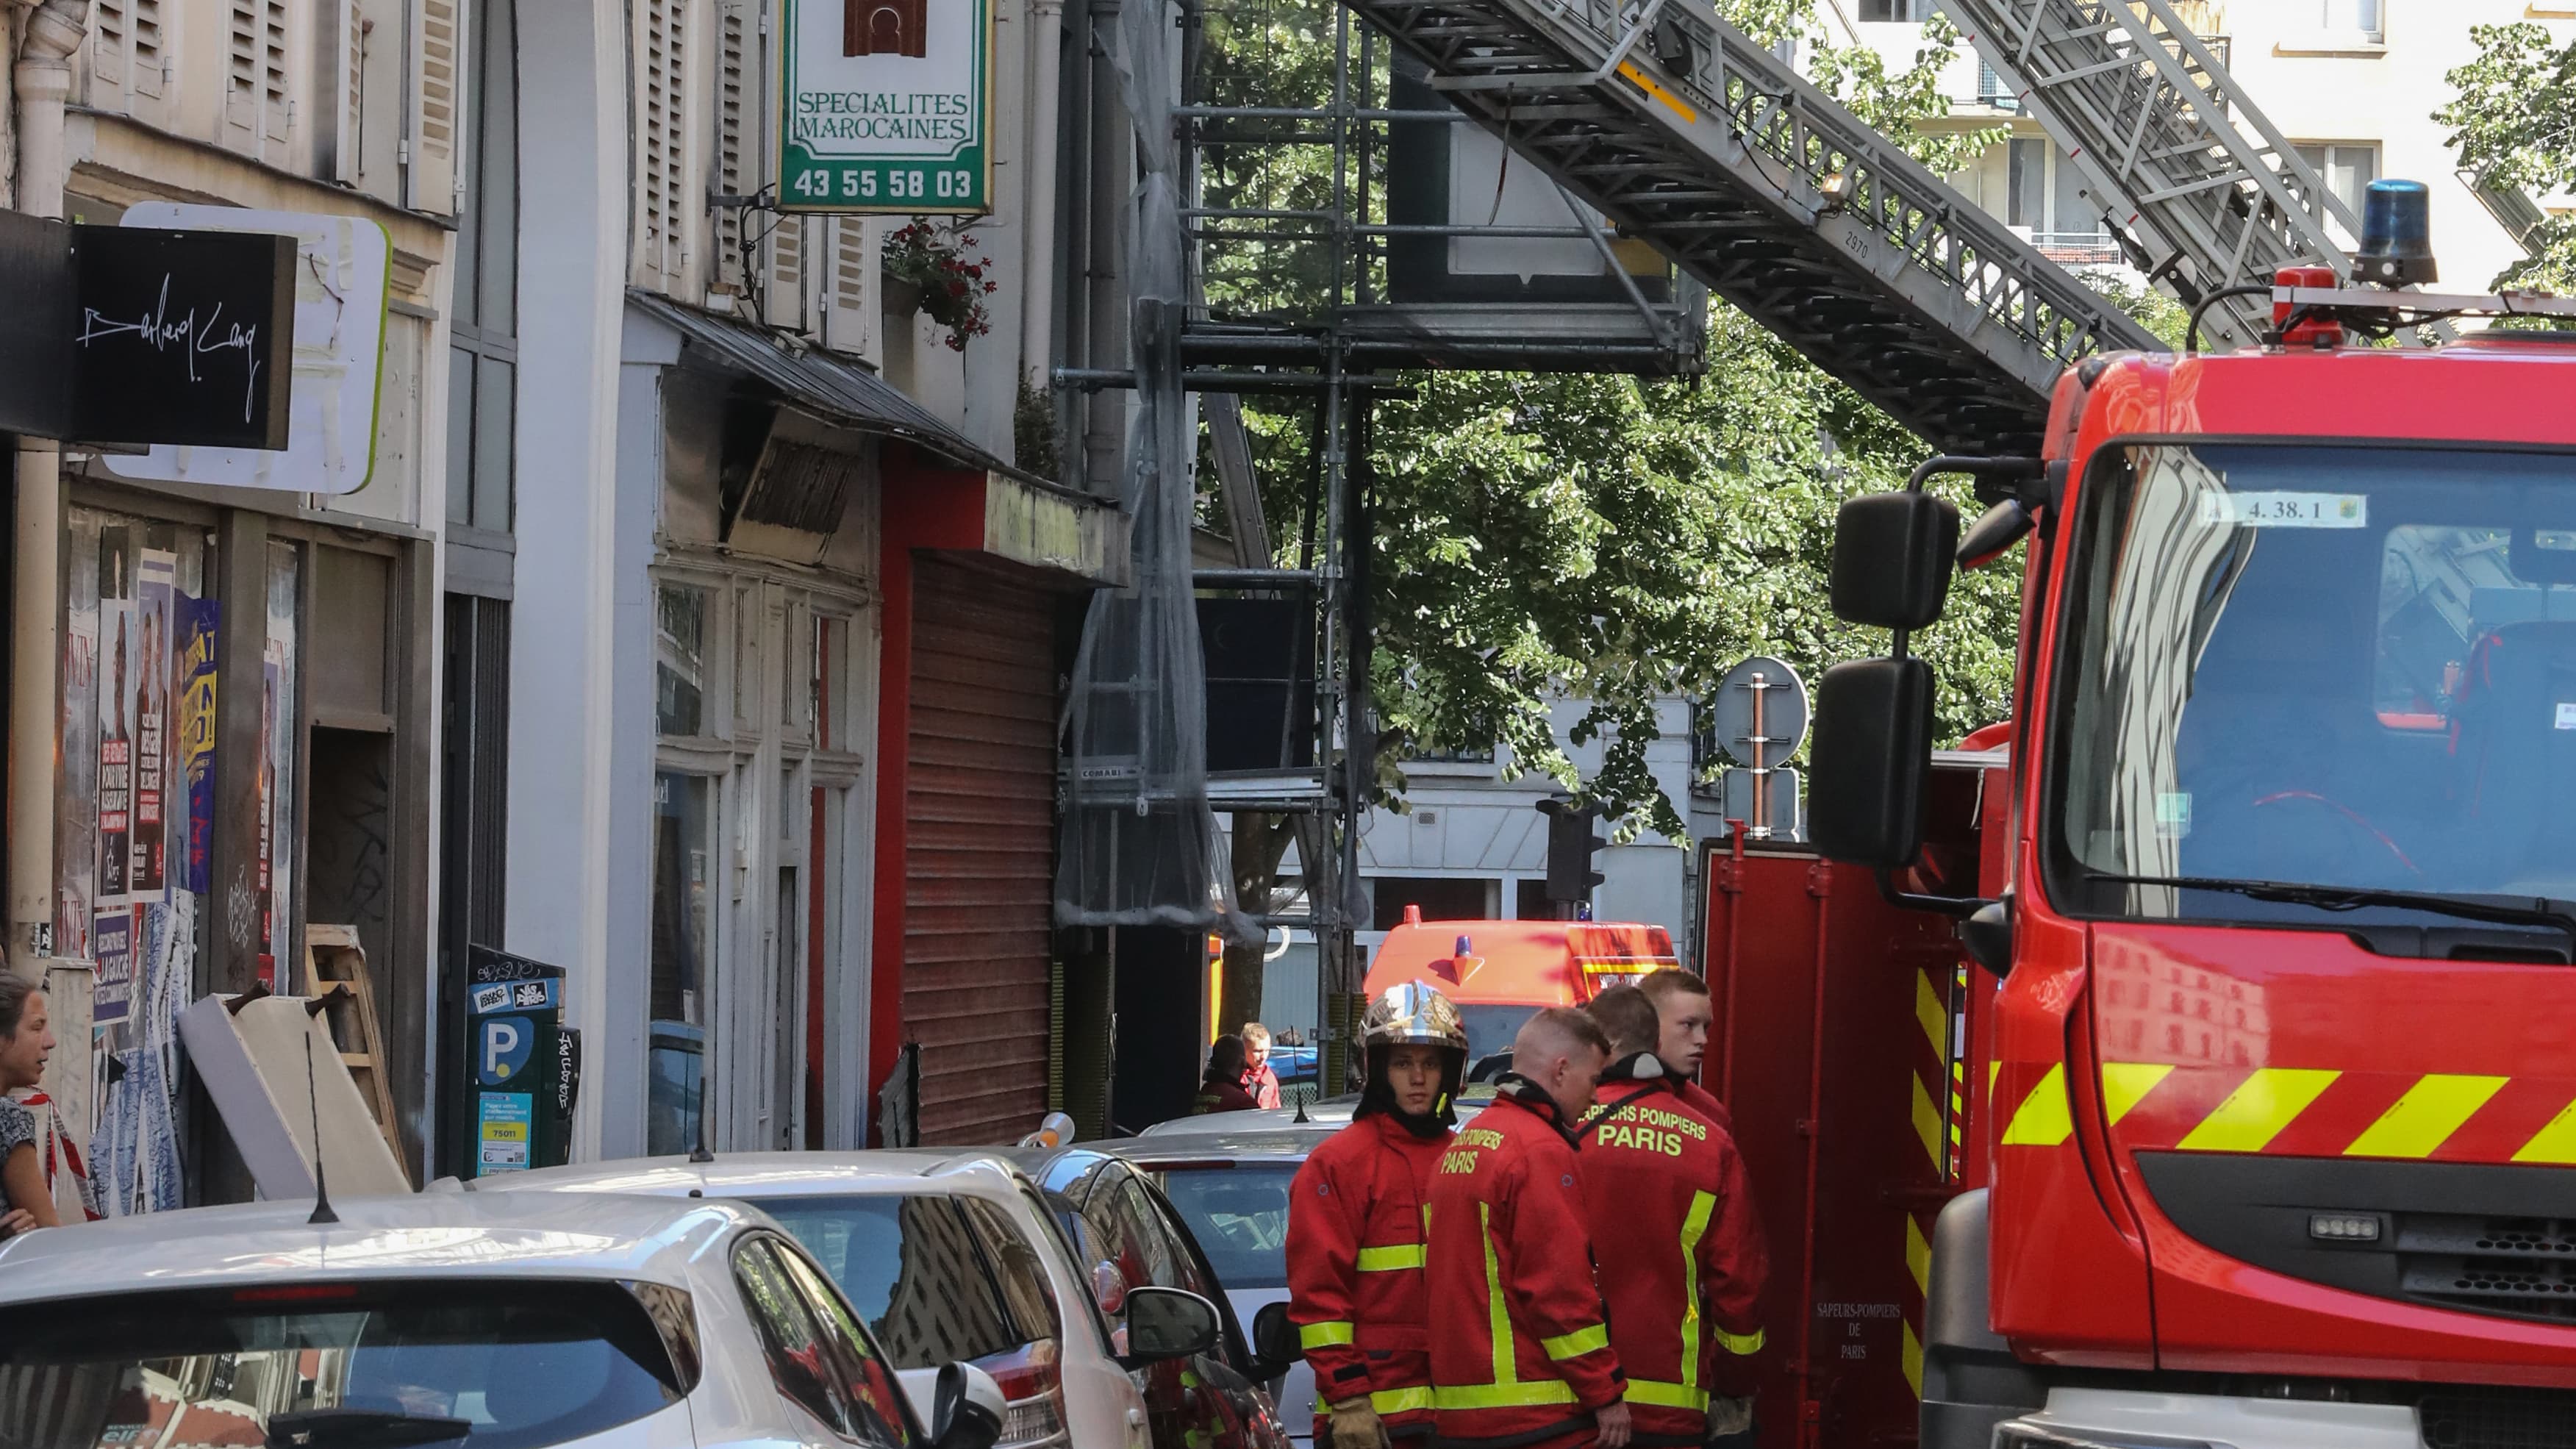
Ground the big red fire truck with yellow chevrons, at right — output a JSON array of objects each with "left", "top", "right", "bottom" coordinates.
[{"left": 1703, "top": 183, "right": 2576, "bottom": 1449}]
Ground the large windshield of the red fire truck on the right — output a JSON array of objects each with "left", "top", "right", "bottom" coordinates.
[{"left": 2056, "top": 446, "right": 2576, "bottom": 923}]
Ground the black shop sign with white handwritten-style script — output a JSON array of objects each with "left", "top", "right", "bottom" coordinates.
[{"left": 0, "top": 219, "right": 296, "bottom": 448}]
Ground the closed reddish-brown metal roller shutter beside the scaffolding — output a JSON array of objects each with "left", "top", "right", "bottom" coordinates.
[{"left": 904, "top": 554, "right": 1056, "bottom": 1142}]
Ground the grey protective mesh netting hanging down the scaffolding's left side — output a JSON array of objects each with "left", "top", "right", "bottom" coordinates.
[{"left": 1056, "top": 3, "right": 1249, "bottom": 931}]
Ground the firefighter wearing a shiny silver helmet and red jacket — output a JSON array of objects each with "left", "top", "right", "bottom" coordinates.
[{"left": 1277, "top": 982, "right": 1466, "bottom": 1449}]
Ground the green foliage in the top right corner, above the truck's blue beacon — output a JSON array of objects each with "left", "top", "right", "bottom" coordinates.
[{"left": 2432, "top": 21, "right": 2576, "bottom": 294}]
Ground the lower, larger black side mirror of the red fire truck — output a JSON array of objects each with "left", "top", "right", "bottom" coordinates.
[{"left": 1806, "top": 657, "right": 1932, "bottom": 869}]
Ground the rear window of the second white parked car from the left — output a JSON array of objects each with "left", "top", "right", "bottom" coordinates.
[{"left": 757, "top": 1194, "right": 1048, "bottom": 1369}]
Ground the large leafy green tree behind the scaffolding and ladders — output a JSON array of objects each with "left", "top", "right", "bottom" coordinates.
[{"left": 1198, "top": 0, "right": 2071, "bottom": 838}]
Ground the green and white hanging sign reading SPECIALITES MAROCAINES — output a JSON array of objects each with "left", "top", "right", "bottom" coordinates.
[{"left": 778, "top": 0, "right": 992, "bottom": 214}]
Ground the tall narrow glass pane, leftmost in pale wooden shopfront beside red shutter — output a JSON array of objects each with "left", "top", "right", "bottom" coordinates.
[{"left": 644, "top": 771, "right": 716, "bottom": 1155}]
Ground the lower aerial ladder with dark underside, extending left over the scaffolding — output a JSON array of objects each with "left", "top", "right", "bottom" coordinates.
[{"left": 1348, "top": 0, "right": 2161, "bottom": 454}]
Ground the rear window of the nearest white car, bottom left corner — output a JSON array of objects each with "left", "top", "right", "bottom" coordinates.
[{"left": 0, "top": 1279, "right": 695, "bottom": 1449}]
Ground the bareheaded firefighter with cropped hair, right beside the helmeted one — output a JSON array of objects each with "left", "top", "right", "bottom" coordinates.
[{"left": 1430, "top": 1006, "right": 1628, "bottom": 1449}]
